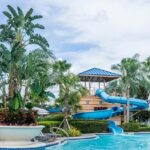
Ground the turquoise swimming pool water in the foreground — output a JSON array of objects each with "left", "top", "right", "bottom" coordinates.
[{"left": 46, "top": 134, "right": 150, "bottom": 150}]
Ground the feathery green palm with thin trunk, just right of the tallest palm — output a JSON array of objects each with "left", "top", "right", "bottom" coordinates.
[{"left": 21, "top": 49, "right": 52, "bottom": 101}]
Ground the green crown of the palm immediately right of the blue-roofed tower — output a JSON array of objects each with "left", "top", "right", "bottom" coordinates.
[{"left": 110, "top": 54, "right": 141, "bottom": 97}]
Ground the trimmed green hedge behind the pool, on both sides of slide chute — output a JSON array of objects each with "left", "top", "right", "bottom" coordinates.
[{"left": 38, "top": 119, "right": 150, "bottom": 133}]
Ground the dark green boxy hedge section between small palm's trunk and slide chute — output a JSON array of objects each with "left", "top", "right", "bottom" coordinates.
[{"left": 69, "top": 120, "right": 108, "bottom": 133}]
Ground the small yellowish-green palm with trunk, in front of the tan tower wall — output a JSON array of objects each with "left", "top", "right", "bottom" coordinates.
[{"left": 58, "top": 73, "right": 88, "bottom": 129}]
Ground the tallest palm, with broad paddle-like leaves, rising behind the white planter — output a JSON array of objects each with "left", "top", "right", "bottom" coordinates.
[{"left": 0, "top": 5, "right": 52, "bottom": 109}]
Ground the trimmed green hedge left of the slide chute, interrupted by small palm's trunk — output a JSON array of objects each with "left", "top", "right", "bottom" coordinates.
[{"left": 38, "top": 120, "right": 108, "bottom": 133}]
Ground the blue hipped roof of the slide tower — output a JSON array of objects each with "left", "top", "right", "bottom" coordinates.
[{"left": 78, "top": 68, "right": 121, "bottom": 82}]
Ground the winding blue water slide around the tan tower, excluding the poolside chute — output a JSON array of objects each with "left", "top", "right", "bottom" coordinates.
[{"left": 73, "top": 89, "right": 148, "bottom": 119}]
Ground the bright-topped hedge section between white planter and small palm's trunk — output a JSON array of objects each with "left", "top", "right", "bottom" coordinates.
[{"left": 38, "top": 121, "right": 61, "bottom": 133}]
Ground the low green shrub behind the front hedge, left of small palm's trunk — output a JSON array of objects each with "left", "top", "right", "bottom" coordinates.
[{"left": 38, "top": 114, "right": 64, "bottom": 121}]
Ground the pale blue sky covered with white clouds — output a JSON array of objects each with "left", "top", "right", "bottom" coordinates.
[{"left": 0, "top": 0, "right": 150, "bottom": 73}]
